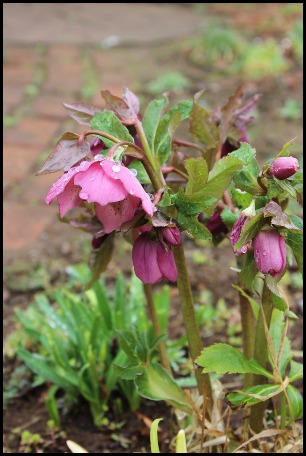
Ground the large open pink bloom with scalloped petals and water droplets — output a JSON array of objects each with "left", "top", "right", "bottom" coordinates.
[{"left": 46, "top": 154, "right": 155, "bottom": 234}]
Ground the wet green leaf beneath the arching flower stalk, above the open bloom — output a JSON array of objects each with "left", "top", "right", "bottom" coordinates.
[{"left": 91, "top": 109, "right": 134, "bottom": 147}]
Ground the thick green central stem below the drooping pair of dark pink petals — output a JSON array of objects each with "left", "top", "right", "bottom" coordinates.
[{"left": 173, "top": 244, "right": 213, "bottom": 410}]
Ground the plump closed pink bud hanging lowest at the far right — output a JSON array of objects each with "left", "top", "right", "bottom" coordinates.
[{"left": 254, "top": 230, "right": 286, "bottom": 278}]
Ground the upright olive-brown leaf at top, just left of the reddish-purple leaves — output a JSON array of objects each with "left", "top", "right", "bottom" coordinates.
[{"left": 190, "top": 90, "right": 219, "bottom": 149}]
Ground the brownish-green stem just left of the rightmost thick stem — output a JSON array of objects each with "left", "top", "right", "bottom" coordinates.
[{"left": 239, "top": 287, "right": 256, "bottom": 386}]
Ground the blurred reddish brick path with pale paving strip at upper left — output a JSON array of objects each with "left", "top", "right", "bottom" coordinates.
[{"left": 3, "top": 3, "right": 203, "bottom": 253}]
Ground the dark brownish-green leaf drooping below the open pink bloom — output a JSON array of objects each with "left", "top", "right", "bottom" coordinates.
[{"left": 85, "top": 232, "right": 115, "bottom": 290}]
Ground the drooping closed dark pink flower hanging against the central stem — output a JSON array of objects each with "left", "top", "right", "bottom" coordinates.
[{"left": 132, "top": 233, "right": 177, "bottom": 284}]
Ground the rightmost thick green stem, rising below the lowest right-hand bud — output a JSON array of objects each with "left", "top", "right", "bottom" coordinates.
[{"left": 250, "top": 281, "right": 273, "bottom": 434}]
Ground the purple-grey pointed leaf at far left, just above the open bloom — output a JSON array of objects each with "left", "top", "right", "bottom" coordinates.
[{"left": 36, "top": 131, "right": 90, "bottom": 175}]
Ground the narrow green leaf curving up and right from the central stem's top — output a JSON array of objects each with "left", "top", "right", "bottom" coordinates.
[{"left": 153, "top": 100, "right": 193, "bottom": 165}]
